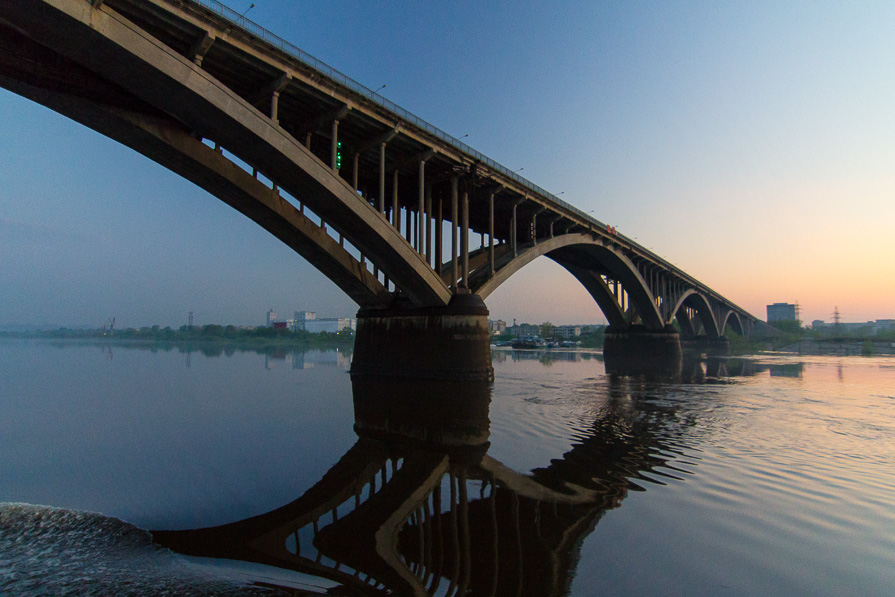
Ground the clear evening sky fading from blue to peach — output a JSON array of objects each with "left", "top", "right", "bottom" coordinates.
[{"left": 0, "top": 0, "right": 895, "bottom": 327}]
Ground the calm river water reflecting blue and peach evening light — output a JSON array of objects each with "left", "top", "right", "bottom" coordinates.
[{"left": 0, "top": 340, "right": 895, "bottom": 595}]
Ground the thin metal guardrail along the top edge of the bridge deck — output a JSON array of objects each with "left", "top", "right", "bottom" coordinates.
[{"left": 152, "top": 0, "right": 748, "bottom": 313}]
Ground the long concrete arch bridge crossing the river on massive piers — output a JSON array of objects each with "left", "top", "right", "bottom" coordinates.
[{"left": 0, "top": 0, "right": 757, "bottom": 378}]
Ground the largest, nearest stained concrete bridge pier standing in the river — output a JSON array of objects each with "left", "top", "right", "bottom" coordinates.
[{"left": 351, "top": 294, "right": 494, "bottom": 381}]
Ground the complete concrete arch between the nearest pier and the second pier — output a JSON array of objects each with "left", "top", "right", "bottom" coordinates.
[{"left": 469, "top": 233, "right": 665, "bottom": 330}]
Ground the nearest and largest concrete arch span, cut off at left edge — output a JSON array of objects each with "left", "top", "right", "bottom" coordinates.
[{"left": 0, "top": 7, "right": 451, "bottom": 307}]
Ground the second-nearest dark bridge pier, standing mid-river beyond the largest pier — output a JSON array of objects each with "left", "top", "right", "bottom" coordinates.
[{"left": 603, "top": 326, "right": 683, "bottom": 376}]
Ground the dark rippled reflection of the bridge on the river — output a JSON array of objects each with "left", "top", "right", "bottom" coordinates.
[{"left": 153, "top": 364, "right": 768, "bottom": 595}]
